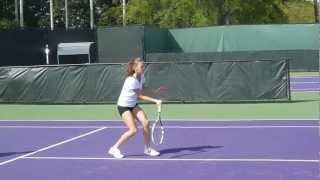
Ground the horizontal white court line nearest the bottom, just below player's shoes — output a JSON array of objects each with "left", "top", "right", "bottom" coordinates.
[{"left": 23, "top": 157, "right": 320, "bottom": 163}]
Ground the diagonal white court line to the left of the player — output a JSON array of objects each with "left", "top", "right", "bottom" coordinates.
[{"left": 0, "top": 127, "right": 107, "bottom": 166}]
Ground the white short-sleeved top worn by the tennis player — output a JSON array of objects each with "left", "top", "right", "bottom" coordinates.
[{"left": 117, "top": 74, "right": 145, "bottom": 107}]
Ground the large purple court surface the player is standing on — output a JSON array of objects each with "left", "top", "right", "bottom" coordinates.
[{"left": 0, "top": 120, "right": 320, "bottom": 180}]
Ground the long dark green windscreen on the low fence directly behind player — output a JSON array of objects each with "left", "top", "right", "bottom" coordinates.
[{"left": 0, "top": 60, "right": 290, "bottom": 104}]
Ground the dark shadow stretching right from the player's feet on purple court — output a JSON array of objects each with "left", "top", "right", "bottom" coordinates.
[{"left": 160, "top": 146, "right": 223, "bottom": 158}]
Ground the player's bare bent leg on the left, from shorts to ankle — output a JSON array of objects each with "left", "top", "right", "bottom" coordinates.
[{"left": 113, "top": 111, "right": 138, "bottom": 148}]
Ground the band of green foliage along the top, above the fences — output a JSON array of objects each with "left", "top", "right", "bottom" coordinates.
[{"left": 0, "top": 0, "right": 315, "bottom": 28}]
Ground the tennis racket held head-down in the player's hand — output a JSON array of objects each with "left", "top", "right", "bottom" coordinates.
[{"left": 151, "top": 101, "right": 164, "bottom": 145}]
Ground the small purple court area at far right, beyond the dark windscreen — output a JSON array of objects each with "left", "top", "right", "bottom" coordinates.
[{"left": 290, "top": 76, "right": 320, "bottom": 92}]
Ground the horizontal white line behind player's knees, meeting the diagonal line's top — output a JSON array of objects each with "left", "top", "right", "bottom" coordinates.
[{"left": 0, "top": 125, "right": 320, "bottom": 129}]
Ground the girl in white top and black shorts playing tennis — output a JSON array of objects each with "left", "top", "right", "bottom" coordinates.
[{"left": 108, "top": 58, "right": 163, "bottom": 158}]
